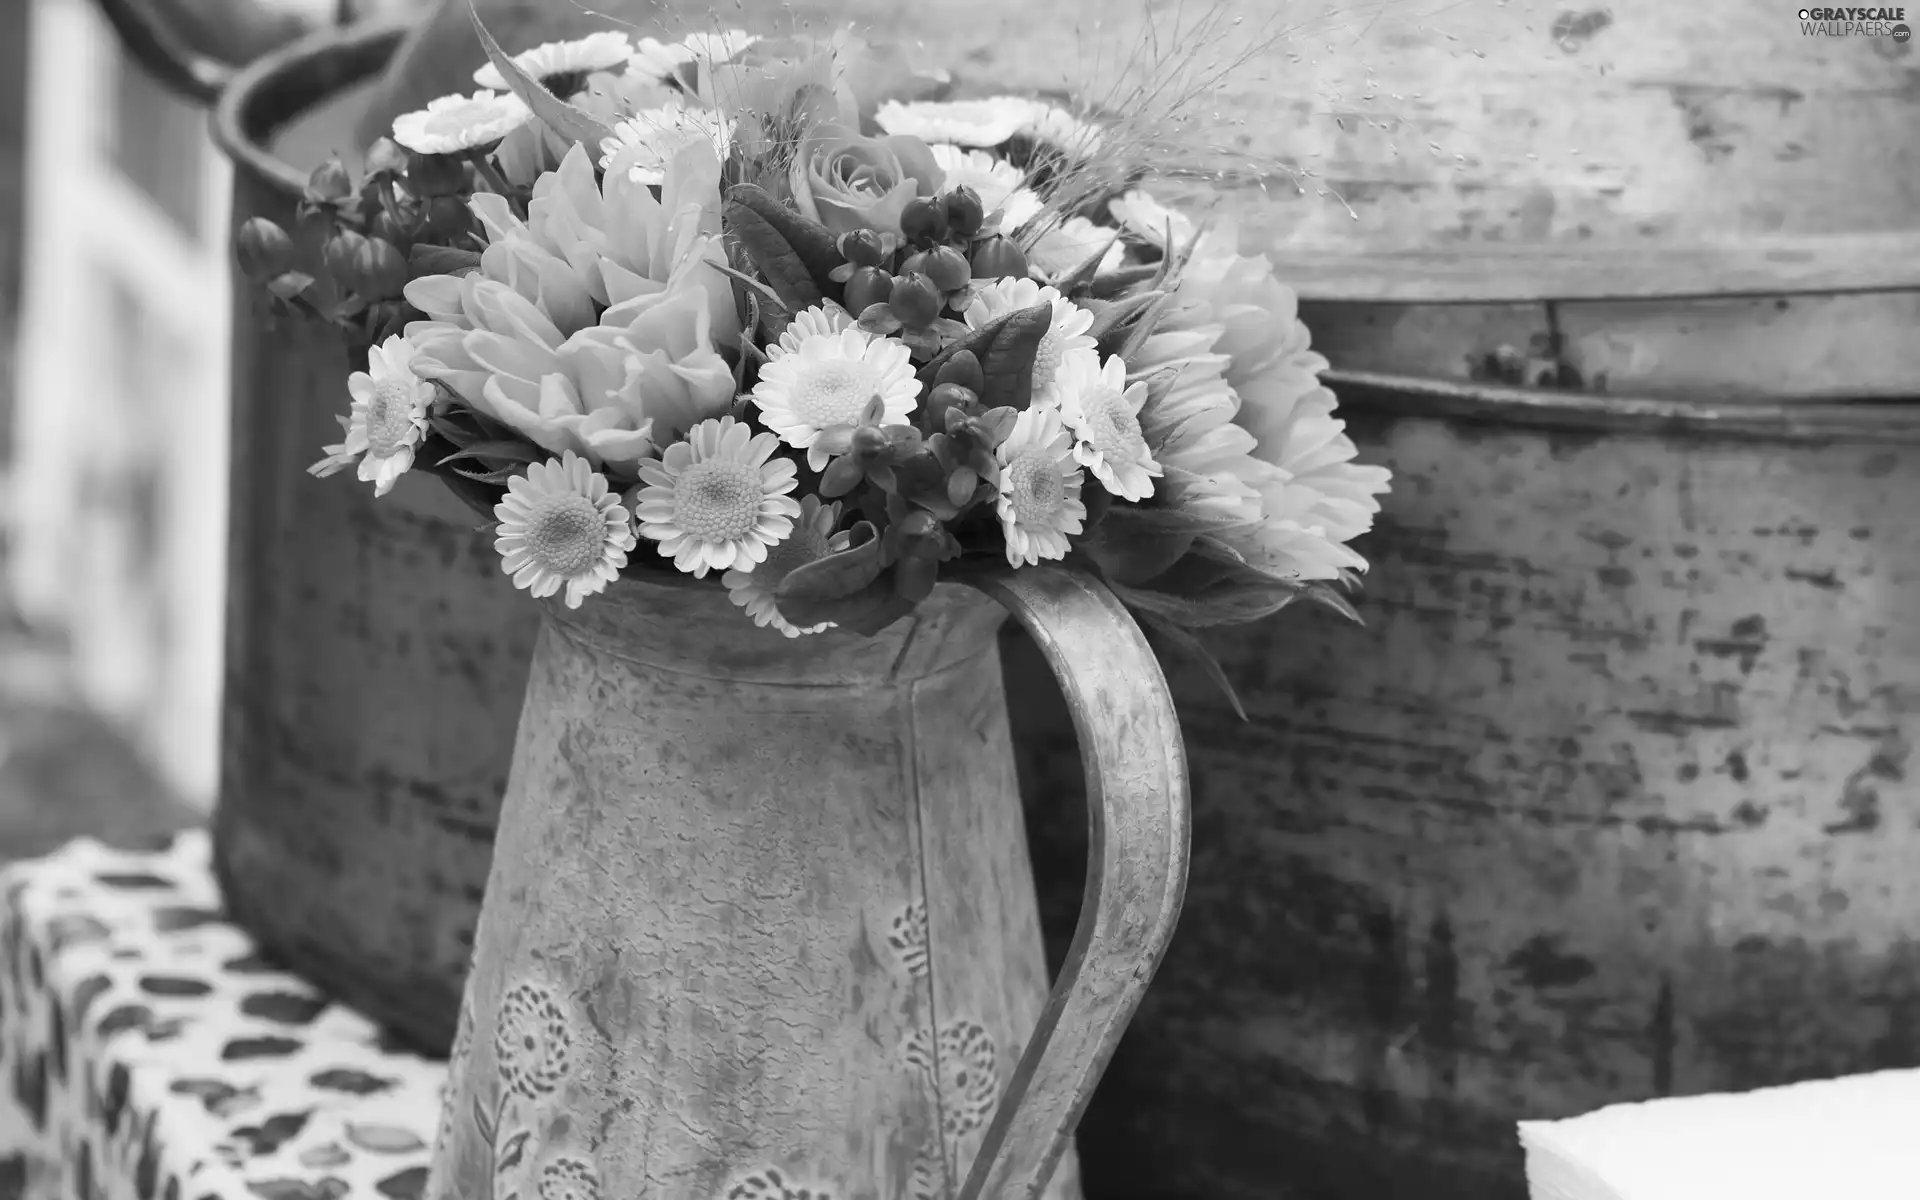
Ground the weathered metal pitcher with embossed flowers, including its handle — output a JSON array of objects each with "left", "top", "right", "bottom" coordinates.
[{"left": 428, "top": 572, "right": 1187, "bottom": 1200}]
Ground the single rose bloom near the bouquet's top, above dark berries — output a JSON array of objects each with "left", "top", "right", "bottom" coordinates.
[{"left": 791, "top": 125, "right": 947, "bottom": 236}]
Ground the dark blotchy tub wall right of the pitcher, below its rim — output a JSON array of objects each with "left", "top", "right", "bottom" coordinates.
[{"left": 1006, "top": 386, "right": 1920, "bottom": 1200}]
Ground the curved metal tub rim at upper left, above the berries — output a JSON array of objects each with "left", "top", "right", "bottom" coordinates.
[{"left": 213, "top": 19, "right": 413, "bottom": 196}]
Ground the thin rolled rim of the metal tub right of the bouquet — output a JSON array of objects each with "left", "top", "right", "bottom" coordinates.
[{"left": 1323, "top": 371, "right": 1920, "bottom": 444}]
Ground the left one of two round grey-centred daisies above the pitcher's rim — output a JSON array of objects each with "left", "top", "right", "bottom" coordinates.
[{"left": 493, "top": 449, "right": 637, "bottom": 609}]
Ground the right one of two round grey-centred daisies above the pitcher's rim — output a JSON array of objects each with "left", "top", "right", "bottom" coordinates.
[{"left": 634, "top": 417, "right": 801, "bottom": 580}]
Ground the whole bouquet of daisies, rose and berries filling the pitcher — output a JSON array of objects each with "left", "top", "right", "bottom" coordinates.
[{"left": 238, "top": 9, "right": 1388, "bottom": 702}]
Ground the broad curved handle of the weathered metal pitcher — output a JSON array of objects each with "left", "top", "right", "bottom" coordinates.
[{"left": 958, "top": 566, "right": 1190, "bottom": 1200}]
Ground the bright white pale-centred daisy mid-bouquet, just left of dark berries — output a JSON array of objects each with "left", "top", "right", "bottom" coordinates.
[{"left": 753, "top": 328, "right": 920, "bottom": 470}]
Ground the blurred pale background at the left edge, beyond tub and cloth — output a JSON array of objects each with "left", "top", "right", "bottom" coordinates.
[{"left": 0, "top": 0, "right": 353, "bottom": 858}]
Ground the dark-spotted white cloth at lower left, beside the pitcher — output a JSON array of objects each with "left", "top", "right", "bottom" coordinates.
[{"left": 0, "top": 829, "right": 445, "bottom": 1200}]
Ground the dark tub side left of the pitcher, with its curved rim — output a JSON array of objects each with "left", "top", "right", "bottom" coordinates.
[{"left": 213, "top": 33, "right": 540, "bottom": 1052}]
